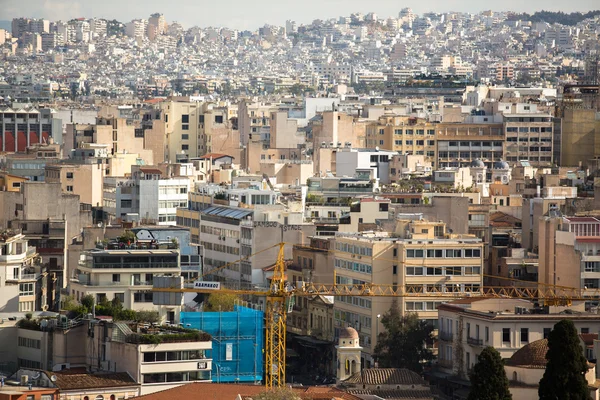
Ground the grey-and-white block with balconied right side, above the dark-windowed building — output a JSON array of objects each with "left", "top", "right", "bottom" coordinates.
[{"left": 103, "top": 165, "right": 191, "bottom": 225}]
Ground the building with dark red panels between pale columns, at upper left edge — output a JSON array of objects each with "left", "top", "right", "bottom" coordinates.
[{"left": 0, "top": 107, "right": 62, "bottom": 153}]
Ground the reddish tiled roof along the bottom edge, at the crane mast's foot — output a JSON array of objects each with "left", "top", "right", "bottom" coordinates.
[{"left": 136, "top": 382, "right": 360, "bottom": 400}]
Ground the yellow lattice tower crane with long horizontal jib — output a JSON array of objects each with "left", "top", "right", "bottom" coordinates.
[{"left": 153, "top": 243, "right": 600, "bottom": 388}]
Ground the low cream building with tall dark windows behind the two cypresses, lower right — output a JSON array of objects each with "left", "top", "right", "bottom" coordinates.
[{"left": 438, "top": 298, "right": 600, "bottom": 379}]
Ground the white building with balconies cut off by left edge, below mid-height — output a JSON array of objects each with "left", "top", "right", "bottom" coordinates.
[{"left": 0, "top": 230, "right": 42, "bottom": 312}]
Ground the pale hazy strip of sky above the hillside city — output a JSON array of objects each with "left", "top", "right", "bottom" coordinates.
[{"left": 0, "top": 0, "right": 598, "bottom": 29}]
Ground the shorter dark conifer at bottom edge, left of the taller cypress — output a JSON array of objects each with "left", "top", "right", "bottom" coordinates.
[{"left": 467, "top": 347, "right": 512, "bottom": 400}]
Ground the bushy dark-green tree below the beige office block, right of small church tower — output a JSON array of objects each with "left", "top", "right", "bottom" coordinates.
[{"left": 375, "top": 299, "right": 433, "bottom": 373}]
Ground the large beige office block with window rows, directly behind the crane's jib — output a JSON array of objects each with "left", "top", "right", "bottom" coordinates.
[{"left": 334, "top": 219, "right": 483, "bottom": 366}]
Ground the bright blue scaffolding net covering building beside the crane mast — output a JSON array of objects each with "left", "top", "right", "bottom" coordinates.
[{"left": 181, "top": 306, "right": 265, "bottom": 383}]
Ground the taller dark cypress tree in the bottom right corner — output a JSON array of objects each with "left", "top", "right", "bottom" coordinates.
[{"left": 538, "top": 320, "right": 590, "bottom": 400}]
